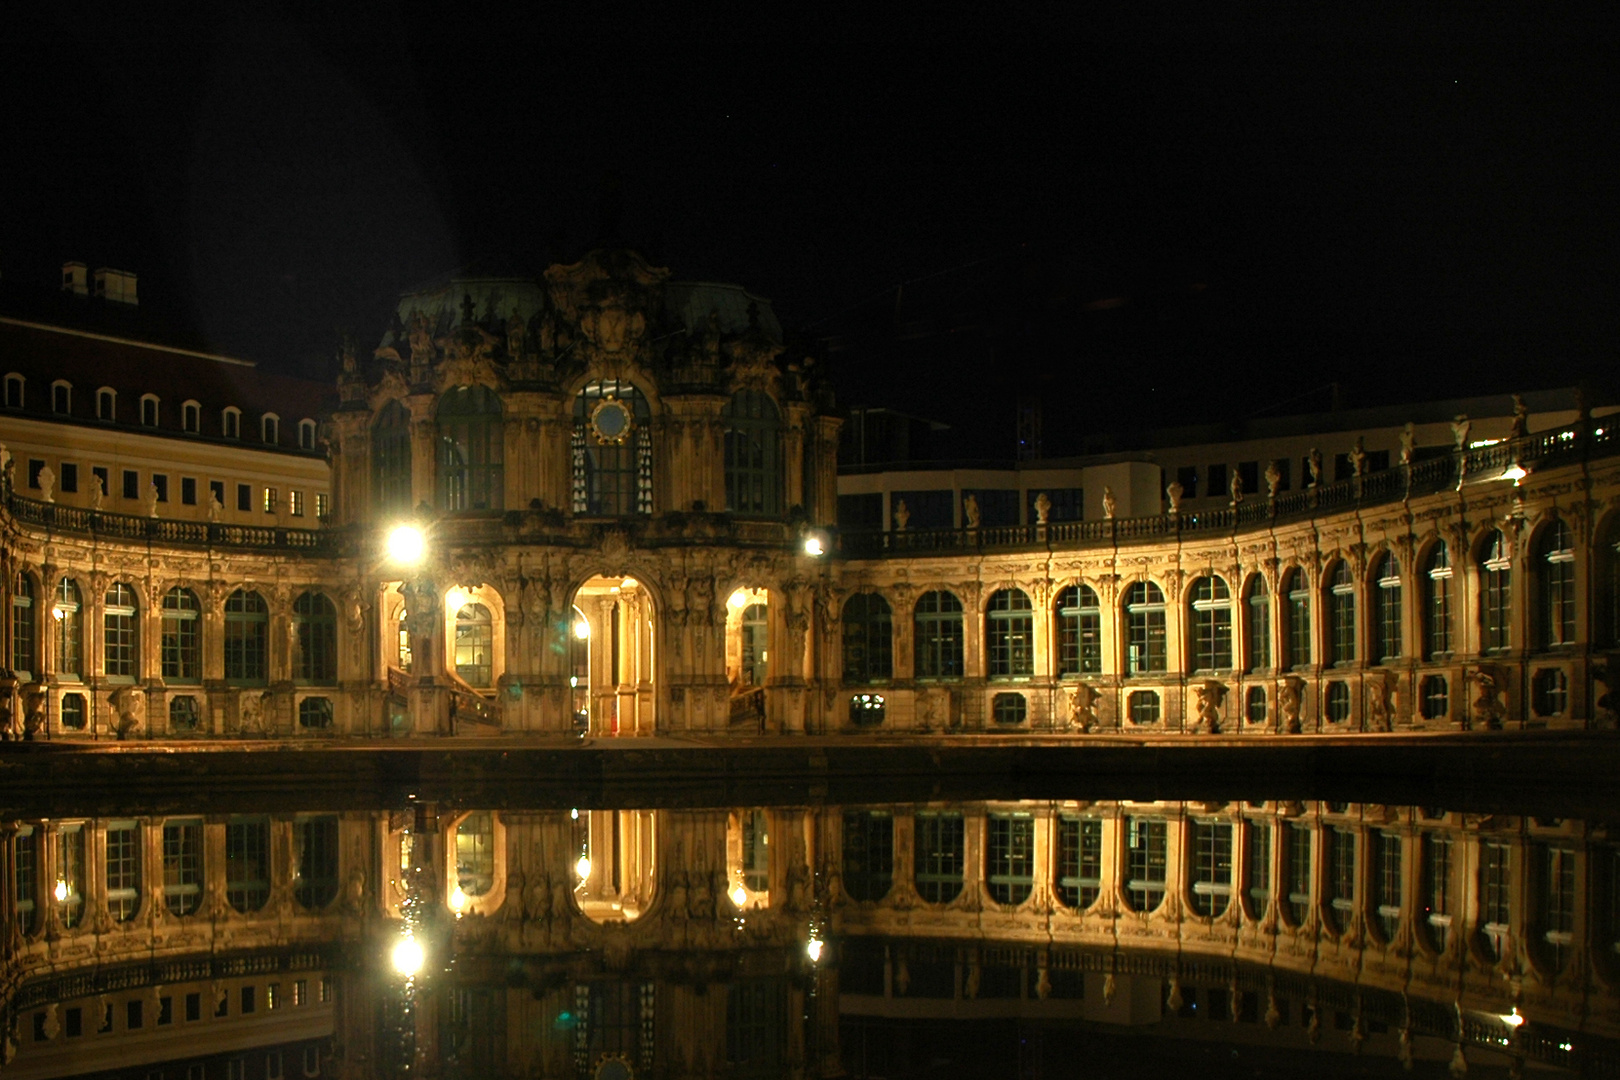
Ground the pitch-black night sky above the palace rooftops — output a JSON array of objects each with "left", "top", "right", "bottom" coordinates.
[{"left": 0, "top": 5, "right": 1620, "bottom": 433}]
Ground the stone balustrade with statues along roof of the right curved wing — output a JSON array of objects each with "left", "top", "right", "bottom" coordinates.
[{"left": 838, "top": 416, "right": 1620, "bottom": 559}]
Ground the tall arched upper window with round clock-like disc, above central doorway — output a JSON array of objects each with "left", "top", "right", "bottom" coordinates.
[{"left": 573, "top": 379, "right": 653, "bottom": 517}]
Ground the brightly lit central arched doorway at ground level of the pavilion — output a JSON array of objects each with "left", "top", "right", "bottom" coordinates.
[{"left": 569, "top": 575, "right": 656, "bottom": 735}]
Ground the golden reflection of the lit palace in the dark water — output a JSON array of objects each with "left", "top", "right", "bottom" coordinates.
[{"left": 0, "top": 800, "right": 1620, "bottom": 1080}]
